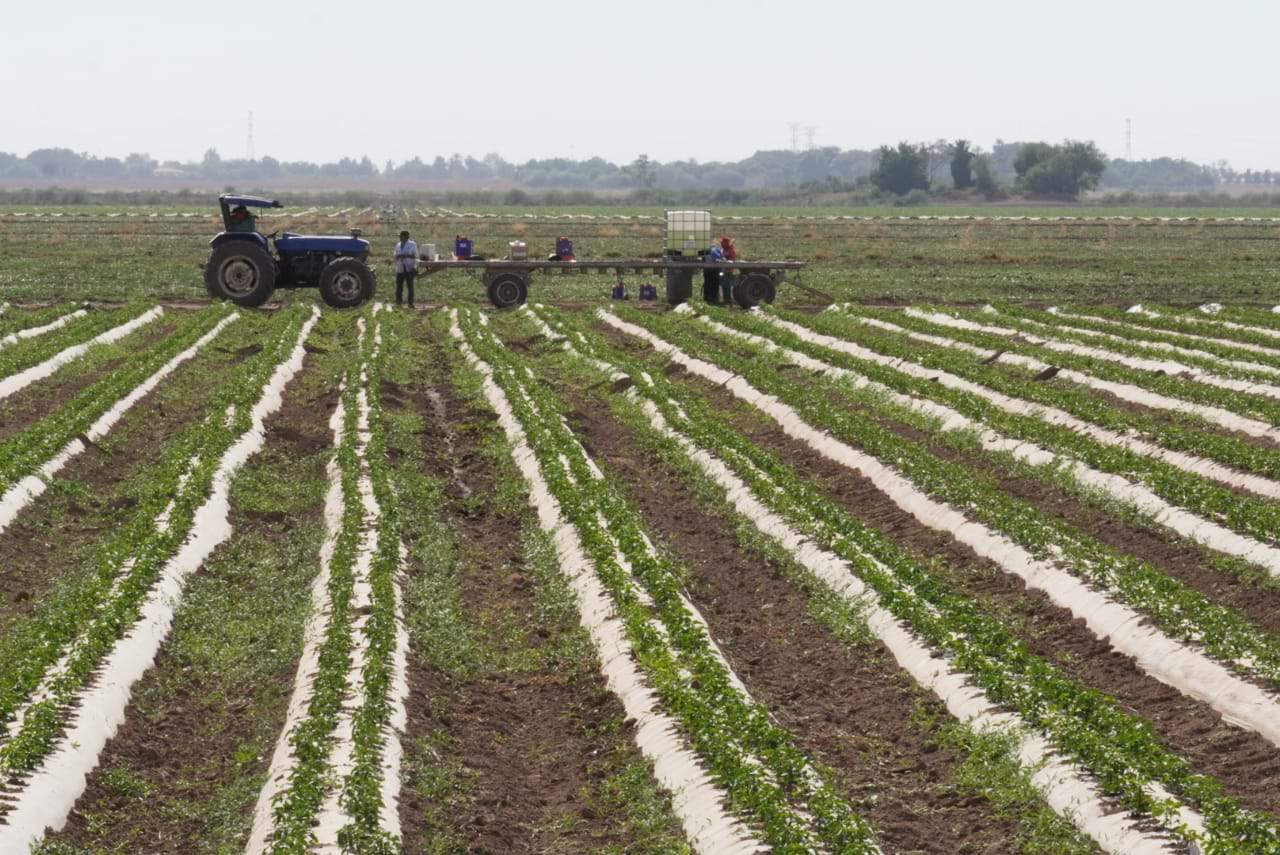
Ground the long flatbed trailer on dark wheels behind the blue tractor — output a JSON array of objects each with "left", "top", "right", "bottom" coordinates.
[{"left": 417, "top": 256, "right": 805, "bottom": 308}]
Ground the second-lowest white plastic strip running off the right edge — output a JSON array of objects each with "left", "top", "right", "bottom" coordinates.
[{"left": 701, "top": 316, "right": 1280, "bottom": 576}]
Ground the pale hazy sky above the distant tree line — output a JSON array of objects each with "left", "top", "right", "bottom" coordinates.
[{"left": 10, "top": 0, "right": 1280, "bottom": 169}]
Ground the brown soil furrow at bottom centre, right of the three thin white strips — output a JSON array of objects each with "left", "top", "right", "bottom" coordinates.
[{"left": 399, "top": 330, "right": 678, "bottom": 855}]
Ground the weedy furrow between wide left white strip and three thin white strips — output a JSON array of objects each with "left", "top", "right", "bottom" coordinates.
[{"left": 43, "top": 345, "right": 337, "bottom": 854}]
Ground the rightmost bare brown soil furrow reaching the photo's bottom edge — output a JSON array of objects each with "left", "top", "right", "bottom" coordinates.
[{"left": 558, "top": 388, "right": 1034, "bottom": 855}]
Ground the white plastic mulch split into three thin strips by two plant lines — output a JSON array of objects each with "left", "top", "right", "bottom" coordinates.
[{"left": 244, "top": 305, "right": 408, "bottom": 855}]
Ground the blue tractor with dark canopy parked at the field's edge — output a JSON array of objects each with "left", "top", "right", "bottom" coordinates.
[{"left": 205, "top": 195, "right": 376, "bottom": 308}]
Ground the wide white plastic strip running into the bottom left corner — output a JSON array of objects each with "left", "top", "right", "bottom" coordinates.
[{"left": 0, "top": 310, "right": 320, "bottom": 852}]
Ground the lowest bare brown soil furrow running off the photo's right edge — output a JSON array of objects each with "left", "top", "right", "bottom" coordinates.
[{"left": 672, "top": 372, "right": 1280, "bottom": 817}]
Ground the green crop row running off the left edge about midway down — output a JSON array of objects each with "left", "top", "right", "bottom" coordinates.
[{"left": 0, "top": 303, "right": 238, "bottom": 494}]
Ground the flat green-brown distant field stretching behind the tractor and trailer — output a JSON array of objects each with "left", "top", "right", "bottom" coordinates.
[{"left": 0, "top": 205, "right": 1280, "bottom": 305}]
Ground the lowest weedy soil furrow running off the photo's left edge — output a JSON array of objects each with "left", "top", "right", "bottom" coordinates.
[{"left": 0, "top": 321, "right": 248, "bottom": 632}]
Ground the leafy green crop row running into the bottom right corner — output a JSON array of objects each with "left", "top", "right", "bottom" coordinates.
[{"left": 529, "top": 303, "right": 1280, "bottom": 855}]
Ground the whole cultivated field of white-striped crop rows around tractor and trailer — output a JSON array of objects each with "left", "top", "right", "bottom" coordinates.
[{"left": 0, "top": 285, "right": 1280, "bottom": 855}]
